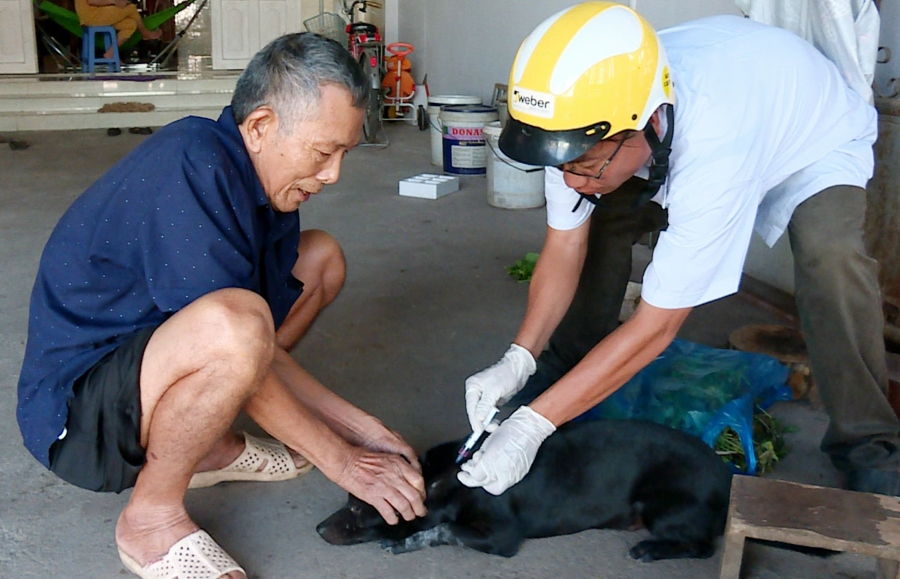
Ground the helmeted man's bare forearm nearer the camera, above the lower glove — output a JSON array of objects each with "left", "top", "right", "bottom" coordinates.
[{"left": 530, "top": 302, "right": 691, "bottom": 426}]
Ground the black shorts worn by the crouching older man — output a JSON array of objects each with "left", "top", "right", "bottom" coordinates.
[{"left": 50, "top": 326, "right": 158, "bottom": 493}]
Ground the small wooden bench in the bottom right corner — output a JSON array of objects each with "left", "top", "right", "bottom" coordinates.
[{"left": 719, "top": 475, "right": 900, "bottom": 579}]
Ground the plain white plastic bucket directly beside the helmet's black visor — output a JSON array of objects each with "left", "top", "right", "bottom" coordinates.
[{"left": 483, "top": 121, "right": 544, "bottom": 209}]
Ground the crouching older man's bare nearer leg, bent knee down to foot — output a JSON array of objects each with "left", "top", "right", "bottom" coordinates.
[{"left": 116, "top": 289, "right": 274, "bottom": 579}]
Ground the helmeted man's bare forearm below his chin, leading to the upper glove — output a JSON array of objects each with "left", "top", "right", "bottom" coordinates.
[{"left": 515, "top": 223, "right": 589, "bottom": 358}]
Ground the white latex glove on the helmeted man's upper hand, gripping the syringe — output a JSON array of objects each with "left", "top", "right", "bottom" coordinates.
[{"left": 466, "top": 344, "right": 537, "bottom": 434}]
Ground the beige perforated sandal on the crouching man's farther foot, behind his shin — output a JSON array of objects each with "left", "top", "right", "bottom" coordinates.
[{"left": 188, "top": 432, "right": 313, "bottom": 489}]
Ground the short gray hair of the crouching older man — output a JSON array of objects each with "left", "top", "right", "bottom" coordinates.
[{"left": 231, "top": 32, "right": 369, "bottom": 133}]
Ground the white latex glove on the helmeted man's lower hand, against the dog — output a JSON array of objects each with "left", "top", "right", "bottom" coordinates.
[{"left": 456, "top": 406, "right": 556, "bottom": 495}]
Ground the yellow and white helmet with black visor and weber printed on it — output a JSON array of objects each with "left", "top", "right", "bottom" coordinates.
[{"left": 499, "top": 2, "right": 675, "bottom": 165}]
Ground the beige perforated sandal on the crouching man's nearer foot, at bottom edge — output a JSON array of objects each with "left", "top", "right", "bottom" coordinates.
[{"left": 119, "top": 530, "right": 247, "bottom": 579}]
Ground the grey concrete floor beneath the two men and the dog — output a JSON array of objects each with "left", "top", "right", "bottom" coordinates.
[{"left": 0, "top": 123, "right": 875, "bottom": 579}]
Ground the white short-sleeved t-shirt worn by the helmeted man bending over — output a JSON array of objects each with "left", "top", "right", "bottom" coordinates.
[{"left": 545, "top": 16, "right": 877, "bottom": 308}]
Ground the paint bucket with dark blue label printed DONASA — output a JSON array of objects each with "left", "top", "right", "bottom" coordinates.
[{"left": 438, "top": 105, "right": 499, "bottom": 175}]
